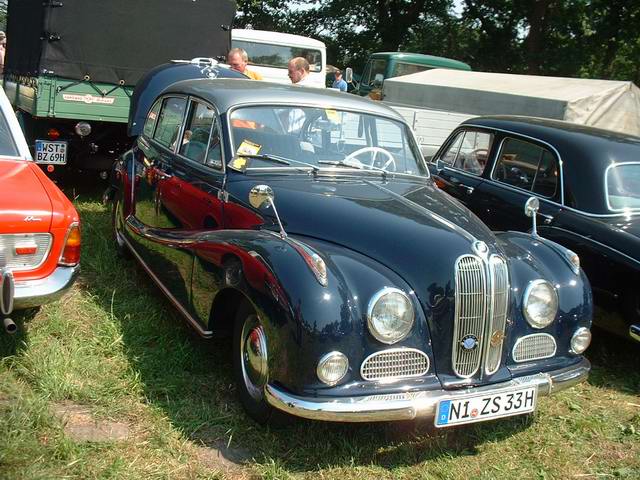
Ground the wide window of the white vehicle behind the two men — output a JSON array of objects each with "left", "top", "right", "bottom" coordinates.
[{"left": 233, "top": 40, "right": 322, "bottom": 72}]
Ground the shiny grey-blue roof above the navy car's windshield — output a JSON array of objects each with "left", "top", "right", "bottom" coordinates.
[{"left": 163, "top": 78, "right": 404, "bottom": 122}]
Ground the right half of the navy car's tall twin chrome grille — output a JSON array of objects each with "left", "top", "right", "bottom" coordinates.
[{"left": 485, "top": 255, "right": 509, "bottom": 375}]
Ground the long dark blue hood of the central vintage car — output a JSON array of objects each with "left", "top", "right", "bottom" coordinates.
[{"left": 229, "top": 176, "right": 500, "bottom": 291}]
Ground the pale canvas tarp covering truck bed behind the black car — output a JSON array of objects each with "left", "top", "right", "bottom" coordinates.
[{"left": 383, "top": 69, "right": 640, "bottom": 136}]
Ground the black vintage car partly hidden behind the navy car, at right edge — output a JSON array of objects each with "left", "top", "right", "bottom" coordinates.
[{"left": 431, "top": 116, "right": 640, "bottom": 341}]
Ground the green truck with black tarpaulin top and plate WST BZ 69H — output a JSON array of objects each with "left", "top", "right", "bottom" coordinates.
[{"left": 4, "top": 0, "right": 236, "bottom": 177}]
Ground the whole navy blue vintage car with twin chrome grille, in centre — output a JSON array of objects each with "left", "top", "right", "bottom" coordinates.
[{"left": 113, "top": 79, "right": 592, "bottom": 427}]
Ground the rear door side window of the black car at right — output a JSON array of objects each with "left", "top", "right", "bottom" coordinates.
[{"left": 493, "top": 138, "right": 559, "bottom": 197}]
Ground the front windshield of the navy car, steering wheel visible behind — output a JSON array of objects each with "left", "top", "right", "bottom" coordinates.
[{"left": 230, "top": 105, "right": 428, "bottom": 176}]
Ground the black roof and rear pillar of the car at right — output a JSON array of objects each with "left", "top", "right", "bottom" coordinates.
[{"left": 461, "top": 115, "right": 640, "bottom": 214}]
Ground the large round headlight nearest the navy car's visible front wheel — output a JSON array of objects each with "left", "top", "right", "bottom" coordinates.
[{"left": 367, "top": 288, "right": 414, "bottom": 344}]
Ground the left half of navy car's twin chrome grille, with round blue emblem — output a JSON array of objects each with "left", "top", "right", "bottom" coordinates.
[{"left": 452, "top": 255, "right": 487, "bottom": 377}]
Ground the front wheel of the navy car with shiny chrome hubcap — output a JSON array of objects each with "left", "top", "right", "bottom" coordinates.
[{"left": 233, "top": 301, "right": 289, "bottom": 426}]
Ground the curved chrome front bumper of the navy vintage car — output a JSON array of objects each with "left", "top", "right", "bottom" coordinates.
[{"left": 265, "top": 358, "right": 591, "bottom": 422}]
